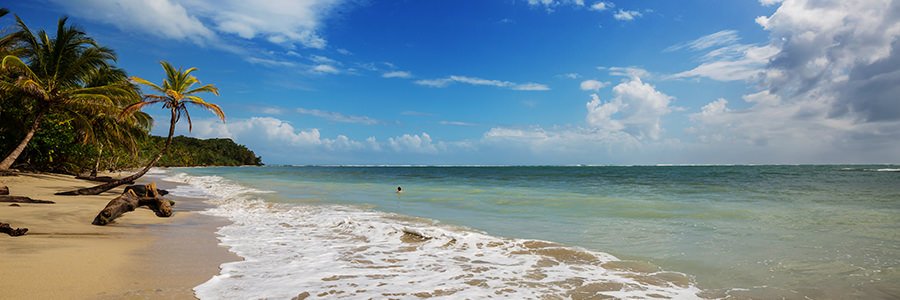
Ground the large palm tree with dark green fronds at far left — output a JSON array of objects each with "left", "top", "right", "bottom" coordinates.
[{"left": 0, "top": 17, "right": 130, "bottom": 170}]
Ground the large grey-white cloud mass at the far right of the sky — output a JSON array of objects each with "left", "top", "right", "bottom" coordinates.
[{"left": 684, "top": 0, "right": 900, "bottom": 161}]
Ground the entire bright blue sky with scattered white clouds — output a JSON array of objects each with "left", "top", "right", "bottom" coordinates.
[{"left": 7, "top": 0, "right": 900, "bottom": 165}]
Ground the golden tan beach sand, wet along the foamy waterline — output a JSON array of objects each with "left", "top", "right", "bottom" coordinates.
[{"left": 0, "top": 173, "right": 240, "bottom": 299}]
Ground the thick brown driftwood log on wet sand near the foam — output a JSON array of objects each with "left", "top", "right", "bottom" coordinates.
[{"left": 91, "top": 183, "right": 173, "bottom": 226}]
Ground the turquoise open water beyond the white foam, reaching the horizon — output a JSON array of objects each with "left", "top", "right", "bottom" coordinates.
[{"left": 178, "top": 165, "right": 900, "bottom": 298}]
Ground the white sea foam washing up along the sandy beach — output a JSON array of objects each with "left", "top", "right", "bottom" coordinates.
[{"left": 167, "top": 173, "right": 699, "bottom": 299}]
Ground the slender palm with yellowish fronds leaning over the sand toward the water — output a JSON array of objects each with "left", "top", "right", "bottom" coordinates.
[{"left": 57, "top": 61, "right": 225, "bottom": 195}]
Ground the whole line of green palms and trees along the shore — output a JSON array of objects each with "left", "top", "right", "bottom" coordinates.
[{"left": 0, "top": 9, "right": 260, "bottom": 194}]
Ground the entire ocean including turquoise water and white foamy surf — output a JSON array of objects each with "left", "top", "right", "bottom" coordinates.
[{"left": 155, "top": 165, "right": 900, "bottom": 299}]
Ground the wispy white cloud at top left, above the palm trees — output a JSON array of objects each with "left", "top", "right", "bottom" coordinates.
[{"left": 52, "top": 0, "right": 344, "bottom": 49}]
